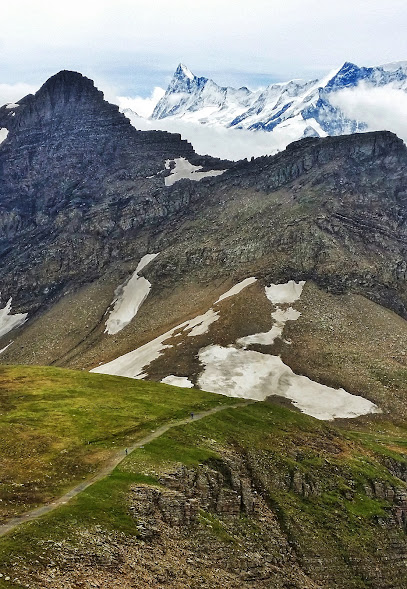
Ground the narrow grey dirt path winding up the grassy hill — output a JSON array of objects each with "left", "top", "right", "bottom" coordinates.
[{"left": 0, "top": 401, "right": 250, "bottom": 537}]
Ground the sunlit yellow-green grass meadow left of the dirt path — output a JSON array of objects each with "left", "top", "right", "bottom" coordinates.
[{"left": 0, "top": 366, "right": 239, "bottom": 518}]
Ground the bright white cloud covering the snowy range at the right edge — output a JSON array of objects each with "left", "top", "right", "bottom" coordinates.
[{"left": 329, "top": 82, "right": 407, "bottom": 142}]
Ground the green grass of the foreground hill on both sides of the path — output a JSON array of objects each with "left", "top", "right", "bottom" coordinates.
[{"left": 0, "top": 367, "right": 407, "bottom": 589}]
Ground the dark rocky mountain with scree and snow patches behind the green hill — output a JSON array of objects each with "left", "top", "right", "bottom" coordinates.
[{"left": 0, "top": 70, "right": 407, "bottom": 418}]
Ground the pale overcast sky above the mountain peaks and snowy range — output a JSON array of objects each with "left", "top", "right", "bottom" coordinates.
[{"left": 0, "top": 0, "right": 407, "bottom": 102}]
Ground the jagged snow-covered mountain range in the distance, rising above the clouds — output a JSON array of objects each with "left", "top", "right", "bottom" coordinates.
[{"left": 152, "top": 62, "right": 407, "bottom": 144}]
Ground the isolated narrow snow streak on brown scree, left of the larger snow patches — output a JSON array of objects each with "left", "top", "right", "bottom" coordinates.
[{"left": 105, "top": 254, "right": 158, "bottom": 335}]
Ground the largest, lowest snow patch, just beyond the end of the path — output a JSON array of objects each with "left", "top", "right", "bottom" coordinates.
[{"left": 197, "top": 345, "right": 380, "bottom": 420}]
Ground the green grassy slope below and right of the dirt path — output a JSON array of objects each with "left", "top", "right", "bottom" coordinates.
[{"left": 0, "top": 403, "right": 407, "bottom": 589}]
